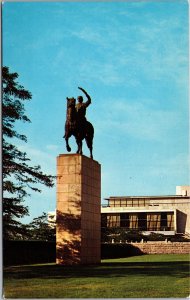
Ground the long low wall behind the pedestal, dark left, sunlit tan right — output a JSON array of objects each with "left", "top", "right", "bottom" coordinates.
[{"left": 3, "top": 241, "right": 190, "bottom": 265}]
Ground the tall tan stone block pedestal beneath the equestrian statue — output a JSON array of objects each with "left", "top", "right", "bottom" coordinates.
[{"left": 56, "top": 154, "right": 101, "bottom": 265}]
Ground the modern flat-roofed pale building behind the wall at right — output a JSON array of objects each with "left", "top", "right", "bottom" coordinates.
[{"left": 101, "top": 186, "right": 190, "bottom": 235}]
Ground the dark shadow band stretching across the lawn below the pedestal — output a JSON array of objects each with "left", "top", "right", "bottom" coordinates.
[{"left": 4, "top": 261, "right": 189, "bottom": 279}]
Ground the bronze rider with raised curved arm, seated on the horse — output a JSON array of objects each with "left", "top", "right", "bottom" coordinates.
[{"left": 76, "top": 87, "right": 91, "bottom": 127}]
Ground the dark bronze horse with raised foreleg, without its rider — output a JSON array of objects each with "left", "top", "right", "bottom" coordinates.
[{"left": 64, "top": 97, "right": 94, "bottom": 158}]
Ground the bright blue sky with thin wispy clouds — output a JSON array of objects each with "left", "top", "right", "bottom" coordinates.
[{"left": 3, "top": 1, "right": 189, "bottom": 221}]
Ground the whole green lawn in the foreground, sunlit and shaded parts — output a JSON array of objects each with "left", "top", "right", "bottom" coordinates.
[{"left": 4, "top": 254, "right": 190, "bottom": 299}]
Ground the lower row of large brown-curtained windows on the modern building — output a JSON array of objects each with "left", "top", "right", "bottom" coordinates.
[{"left": 101, "top": 212, "right": 174, "bottom": 231}]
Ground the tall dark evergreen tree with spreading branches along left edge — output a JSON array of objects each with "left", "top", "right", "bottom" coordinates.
[{"left": 2, "top": 67, "right": 54, "bottom": 239}]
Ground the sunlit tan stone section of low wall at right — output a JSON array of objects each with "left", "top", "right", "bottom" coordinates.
[{"left": 131, "top": 242, "right": 190, "bottom": 254}]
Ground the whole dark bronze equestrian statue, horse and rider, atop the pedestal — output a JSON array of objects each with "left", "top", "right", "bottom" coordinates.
[{"left": 64, "top": 87, "right": 94, "bottom": 159}]
